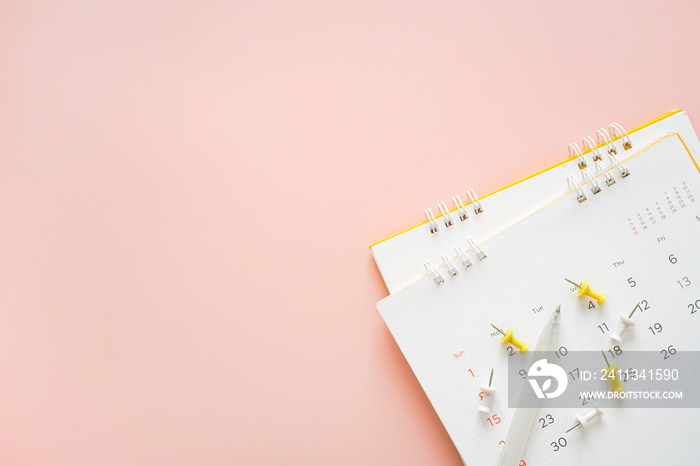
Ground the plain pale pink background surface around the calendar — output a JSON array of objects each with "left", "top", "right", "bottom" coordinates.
[{"left": 0, "top": 0, "right": 700, "bottom": 466}]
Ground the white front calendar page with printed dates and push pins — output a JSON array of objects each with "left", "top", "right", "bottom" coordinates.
[{"left": 377, "top": 133, "right": 700, "bottom": 466}]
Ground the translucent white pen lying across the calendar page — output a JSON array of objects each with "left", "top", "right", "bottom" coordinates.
[{"left": 498, "top": 306, "right": 561, "bottom": 466}]
